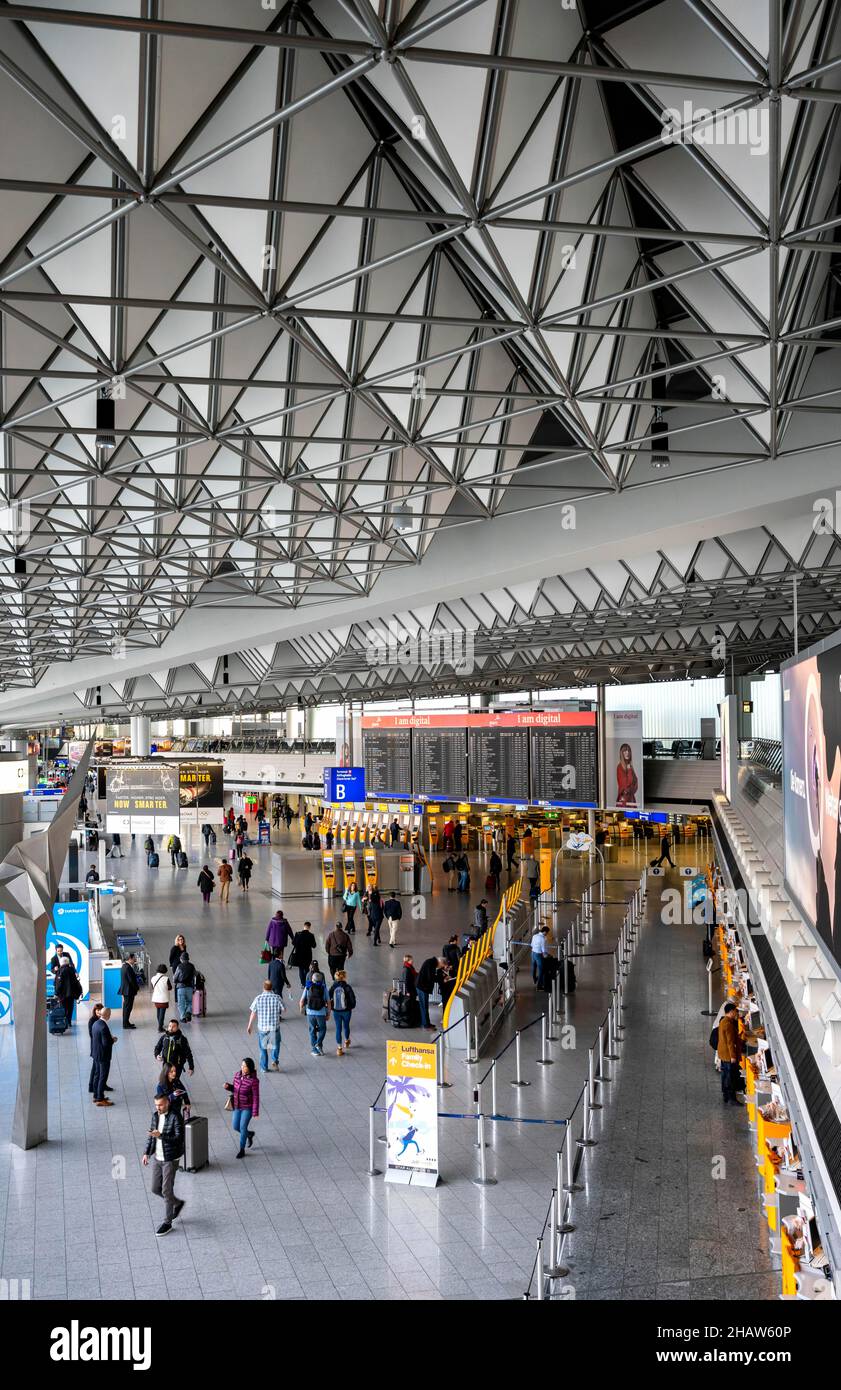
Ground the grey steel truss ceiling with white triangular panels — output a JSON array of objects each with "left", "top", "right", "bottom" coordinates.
[{"left": 0, "top": 0, "right": 841, "bottom": 712}]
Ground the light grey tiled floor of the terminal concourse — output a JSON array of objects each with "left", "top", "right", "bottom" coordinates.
[{"left": 0, "top": 837, "right": 776, "bottom": 1300}]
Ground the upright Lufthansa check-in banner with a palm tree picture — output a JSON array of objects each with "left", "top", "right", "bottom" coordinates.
[{"left": 385, "top": 1040, "right": 438, "bottom": 1187}]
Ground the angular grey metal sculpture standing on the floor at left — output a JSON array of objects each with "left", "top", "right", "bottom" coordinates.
[{"left": 0, "top": 739, "right": 93, "bottom": 1148}]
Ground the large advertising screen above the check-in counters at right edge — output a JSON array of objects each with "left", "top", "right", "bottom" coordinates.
[{"left": 780, "top": 638, "right": 841, "bottom": 960}]
